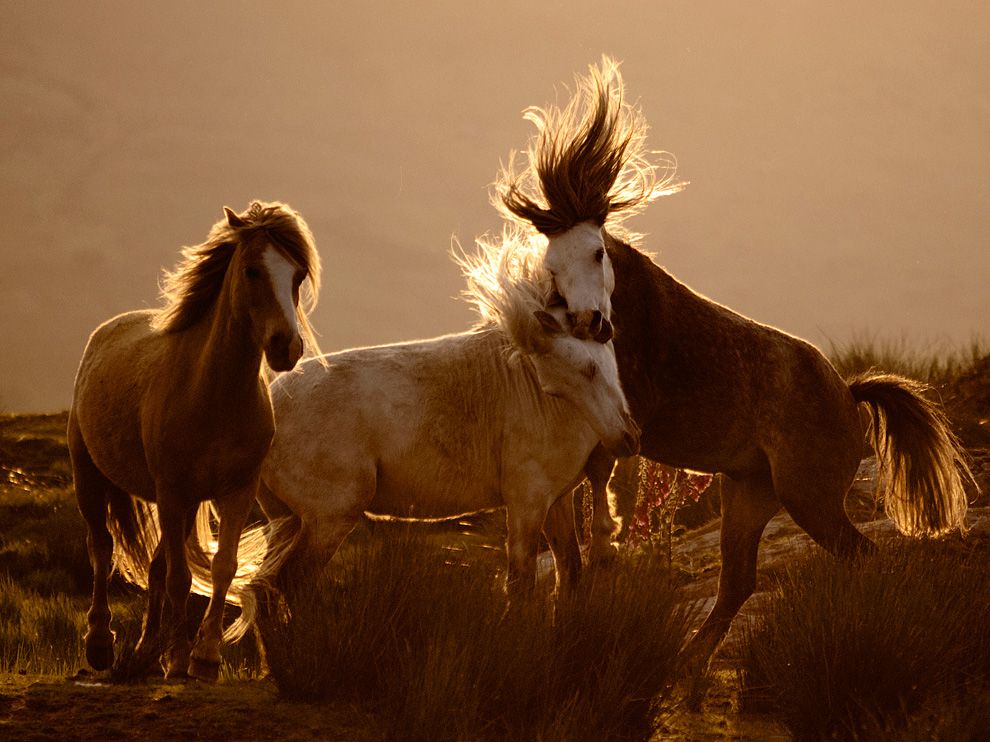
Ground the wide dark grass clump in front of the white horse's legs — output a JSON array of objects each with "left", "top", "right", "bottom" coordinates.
[{"left": 262, "top": 533, "right": 693, "bottom": 740}]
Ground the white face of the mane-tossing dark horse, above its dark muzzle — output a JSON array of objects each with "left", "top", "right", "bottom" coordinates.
[{"left": 544, "top": 222, "right": 615, "bottom": 319}]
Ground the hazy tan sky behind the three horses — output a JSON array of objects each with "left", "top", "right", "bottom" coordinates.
[{"left": 0, "top": 0, "right": 990, "bottom": 412}]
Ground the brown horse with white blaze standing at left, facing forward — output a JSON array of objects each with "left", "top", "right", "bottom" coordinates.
[{"left": 68, "top": 201, "right": 320, "bottom": 679}]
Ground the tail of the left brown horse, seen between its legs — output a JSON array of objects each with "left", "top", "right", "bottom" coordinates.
[{"left": 107, "top": 490, "right": 161, "bottom": 589}]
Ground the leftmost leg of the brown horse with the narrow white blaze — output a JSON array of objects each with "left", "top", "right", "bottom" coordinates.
[{"left": 67, "top": 415, "right": 123, "bottom": 670}]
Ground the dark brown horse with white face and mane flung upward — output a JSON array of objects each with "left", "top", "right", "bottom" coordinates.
[{"left": 496, "top": 59, "right": 972, "bottom": 657}]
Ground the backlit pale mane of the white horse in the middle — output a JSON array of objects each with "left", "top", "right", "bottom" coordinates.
[{"left": 452, "top": 224, "right": 552, "bottom": 353}]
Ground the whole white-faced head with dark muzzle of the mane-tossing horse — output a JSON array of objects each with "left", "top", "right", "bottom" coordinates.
[{"left": 544, "top": 222, "right": 615, "bottom": 343}]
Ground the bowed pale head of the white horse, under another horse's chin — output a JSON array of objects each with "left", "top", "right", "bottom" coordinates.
[{"left": 530, "top": 308, "right": 640, "bottom": 458}]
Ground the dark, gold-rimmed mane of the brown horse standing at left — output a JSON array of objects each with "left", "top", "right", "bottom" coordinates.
[{"left": 155, "top": 201, "right": 320, "bottom": 351}]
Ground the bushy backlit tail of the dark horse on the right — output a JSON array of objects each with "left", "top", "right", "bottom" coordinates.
[{"left": 847, "top": 372, "right": 976, "bottom": 536}]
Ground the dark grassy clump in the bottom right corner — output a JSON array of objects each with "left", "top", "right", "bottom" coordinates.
[{"left": 744, "top": 539, "right": 990, "bottom": 739}]
